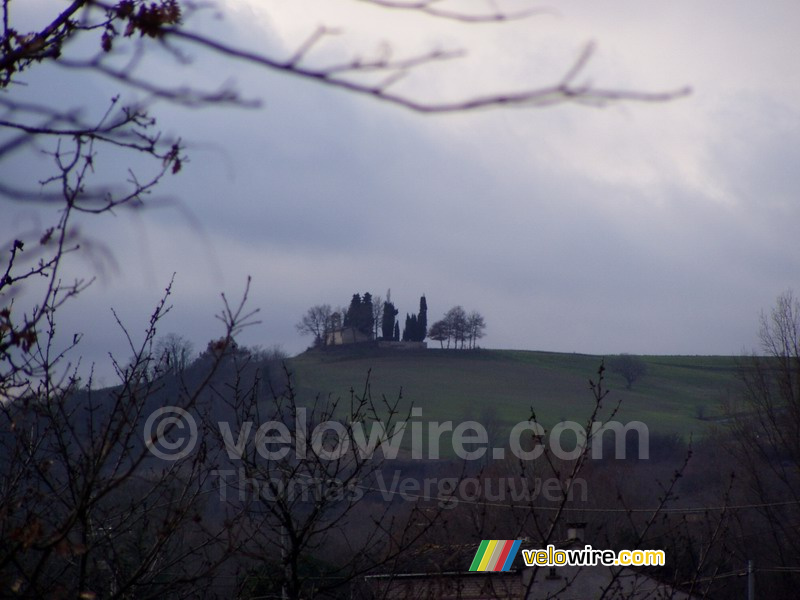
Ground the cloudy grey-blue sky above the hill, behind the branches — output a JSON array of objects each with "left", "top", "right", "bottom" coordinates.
[{"left": 0, "top": 0, "right": 800, "bottom": 383}]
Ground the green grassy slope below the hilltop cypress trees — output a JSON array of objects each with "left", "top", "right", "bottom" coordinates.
[{"left": 289, "top": 345, "right": 737, "bottom": 436}]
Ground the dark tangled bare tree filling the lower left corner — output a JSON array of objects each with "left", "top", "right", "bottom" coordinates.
[{"left": 0, "top": 278, "right": 260, "bottom": 598}]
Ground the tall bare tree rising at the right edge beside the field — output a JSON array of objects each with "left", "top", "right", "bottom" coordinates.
[{"left": 725, "top": 290, "right": 800, "bottom": 597}]
